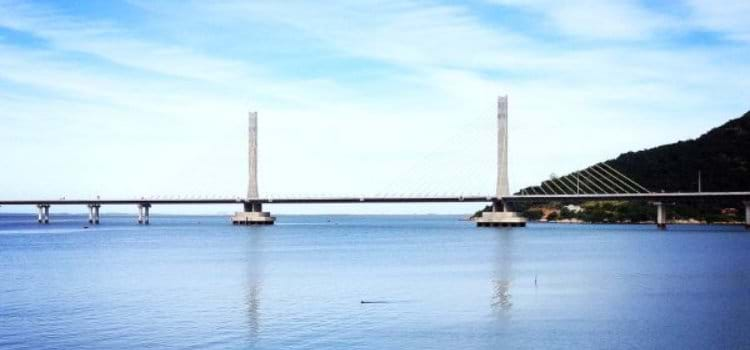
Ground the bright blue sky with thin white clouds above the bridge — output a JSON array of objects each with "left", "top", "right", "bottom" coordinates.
[{"left": 0, "top": 0, "right": 750, "bottom": 213}]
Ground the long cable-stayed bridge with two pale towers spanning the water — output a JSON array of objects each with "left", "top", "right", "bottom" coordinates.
[{"left": 0, "top": 96, "right": 750, "bottom": 229}]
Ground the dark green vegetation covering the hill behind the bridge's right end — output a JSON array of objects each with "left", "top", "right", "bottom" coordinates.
[{"left": 516, "top": 111, "right": 750, "bottom": 222}]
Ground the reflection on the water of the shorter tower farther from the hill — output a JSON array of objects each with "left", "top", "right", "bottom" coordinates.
[{"left": 245, "top": 230, "right": 263, "bottom": 340}]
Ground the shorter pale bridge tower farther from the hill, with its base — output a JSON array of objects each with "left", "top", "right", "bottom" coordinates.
[{"left": 232, "top": 112, "right": 276, "bottom": 225}]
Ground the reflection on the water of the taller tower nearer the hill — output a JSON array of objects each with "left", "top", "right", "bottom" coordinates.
[{"left": 492, "top": 230, "right": 513, "bottom": 313}]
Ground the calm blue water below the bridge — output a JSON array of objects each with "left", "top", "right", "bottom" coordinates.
[{"left": 0, "top": 216, "right": 750, "bottom": 349}]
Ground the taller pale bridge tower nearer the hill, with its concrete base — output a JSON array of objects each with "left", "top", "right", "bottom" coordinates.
[{"left": 476, "top": 95, "right": 526, "bottom": 227}]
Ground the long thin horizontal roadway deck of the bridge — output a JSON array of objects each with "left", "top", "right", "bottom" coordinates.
[{"left": 0, "top": 192, "right": 750, "bottom": 205}]
